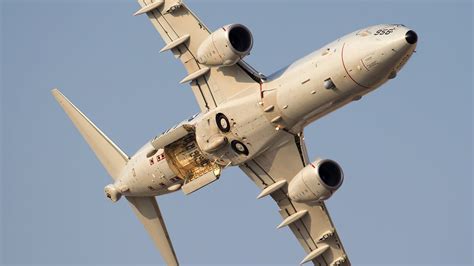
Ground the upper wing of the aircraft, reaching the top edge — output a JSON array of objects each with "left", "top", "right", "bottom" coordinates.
[{"left": 135, "top": 0, "right": 259, "bottom": 111}]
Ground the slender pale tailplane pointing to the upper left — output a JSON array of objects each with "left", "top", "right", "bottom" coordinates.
[{"left": 51, "top": 89, "right": 129, "bottom": 180}]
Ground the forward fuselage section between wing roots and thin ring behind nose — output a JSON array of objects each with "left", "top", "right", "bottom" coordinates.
[{"left": 265, "top": 42, "right": 355, "bottom": 130}]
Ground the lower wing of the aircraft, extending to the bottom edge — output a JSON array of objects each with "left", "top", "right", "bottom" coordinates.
[{"left": 240, "top": 133, "right": 350, "bottom": 265}]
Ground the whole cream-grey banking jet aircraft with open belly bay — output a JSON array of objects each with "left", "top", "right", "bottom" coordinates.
[{"left": 52, "top": 0, "right": 418, "bottom": 265}]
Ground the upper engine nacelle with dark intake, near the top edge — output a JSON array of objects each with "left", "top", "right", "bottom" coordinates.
[{"left": 197, "top": 24, "right": 253, "bottom": 66}]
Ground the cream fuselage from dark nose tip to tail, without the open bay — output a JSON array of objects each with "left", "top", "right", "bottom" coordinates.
[{"left": 116, "top": 25, "right": 416, "bottom": 196}]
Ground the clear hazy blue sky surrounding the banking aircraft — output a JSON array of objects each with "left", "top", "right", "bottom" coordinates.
[{"left": 0, "top": 0, "right": 473, "bottom": 265}]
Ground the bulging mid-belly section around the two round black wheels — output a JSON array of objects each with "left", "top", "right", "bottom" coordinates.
[{"left": 196, "top": 88, "right": 279, "bottom": 166}]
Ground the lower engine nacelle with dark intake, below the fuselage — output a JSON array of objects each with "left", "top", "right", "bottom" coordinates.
[{"left": 288, "top": 159, "right": 344, "bottom": 202}]
